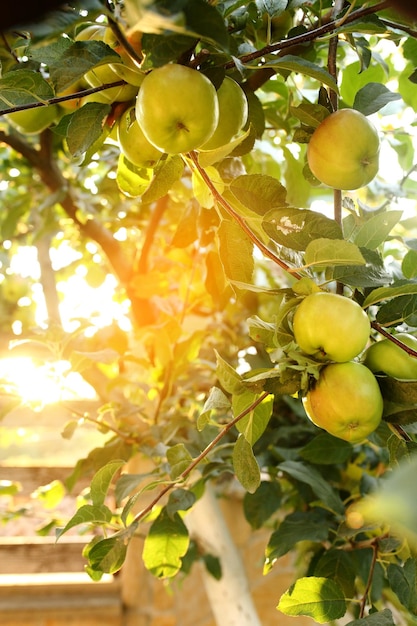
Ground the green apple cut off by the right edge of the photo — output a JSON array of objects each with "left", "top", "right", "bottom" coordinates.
[{"left": 363, "top": 333, "right": 417, "bottom": 380}]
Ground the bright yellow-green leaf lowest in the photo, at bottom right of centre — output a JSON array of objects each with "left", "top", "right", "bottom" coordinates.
[{"left": 277, "top": 576, "right": 346, "bottom": 624}]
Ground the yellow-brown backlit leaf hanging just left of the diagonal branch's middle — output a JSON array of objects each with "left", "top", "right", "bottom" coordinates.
[{"left": 217, "top": 219, "right": 254, "bottom": 283}]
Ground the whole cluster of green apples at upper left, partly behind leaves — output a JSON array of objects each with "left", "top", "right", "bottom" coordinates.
[{"left": 8, "top": 24, "right": 248, "bottom": 160}]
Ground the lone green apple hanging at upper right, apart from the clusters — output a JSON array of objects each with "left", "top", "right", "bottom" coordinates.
[{"left": 307, "top": 109, "right": 379, "bottom": 189}]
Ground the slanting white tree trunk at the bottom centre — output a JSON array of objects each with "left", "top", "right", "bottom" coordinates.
[{"left": 184, "top": 484, "right": 261, "bottom": 626}]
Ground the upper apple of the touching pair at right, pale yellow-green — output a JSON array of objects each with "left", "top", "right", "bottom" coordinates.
[{"left": 293, "top": 291, "right": 371, "bottom": 362}]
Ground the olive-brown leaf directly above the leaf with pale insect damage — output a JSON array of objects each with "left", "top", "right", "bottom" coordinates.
[{"left": 230, "top": 174, "right": 287, "bottom": 215}]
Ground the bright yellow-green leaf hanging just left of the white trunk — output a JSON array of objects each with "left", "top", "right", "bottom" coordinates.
[{"left": 142, "top": 508, "right": 190, "bottom": 578}]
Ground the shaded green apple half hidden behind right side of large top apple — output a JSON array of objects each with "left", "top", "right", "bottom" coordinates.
[{"left": 201, "top": 76, "right": 248, "bottom": 150}]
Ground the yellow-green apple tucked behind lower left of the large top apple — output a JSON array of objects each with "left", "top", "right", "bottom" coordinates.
[{"left": 117, "top": 107, "right": 163, "bottom": 167}]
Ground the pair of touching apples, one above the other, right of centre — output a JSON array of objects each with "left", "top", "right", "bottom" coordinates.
[{"left": 293, "top": 291, "right": 383, "bottom": 444}]
